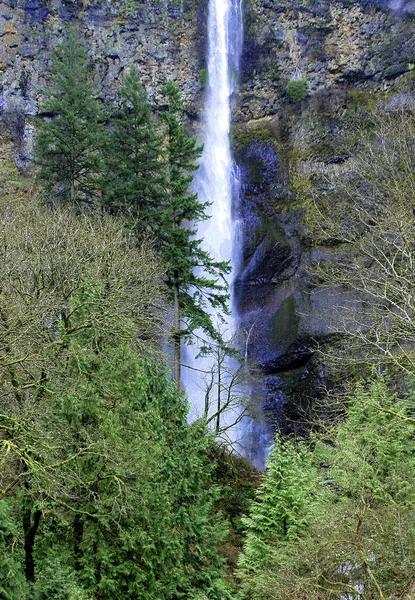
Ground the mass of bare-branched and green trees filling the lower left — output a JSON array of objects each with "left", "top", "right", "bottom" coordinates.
[{"left": 0, "top": 188, "right": 231, "bottom": 600}]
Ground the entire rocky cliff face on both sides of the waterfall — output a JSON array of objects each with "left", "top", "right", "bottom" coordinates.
[{"left": 0, "top": 0, "right": 415, "bottom": 440}]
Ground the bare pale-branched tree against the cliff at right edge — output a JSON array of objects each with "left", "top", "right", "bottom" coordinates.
[{"left": 312, "top": 107, "right": 415, "bottom": 374}]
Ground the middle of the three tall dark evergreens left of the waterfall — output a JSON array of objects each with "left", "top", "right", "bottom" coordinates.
[{"left": 102, "top": 66, "right": 165, "bottom": 235}]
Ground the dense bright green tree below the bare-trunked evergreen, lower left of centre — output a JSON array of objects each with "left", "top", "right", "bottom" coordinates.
[{"left": 48, "top": 340, "right": 226, "bottom": 600}]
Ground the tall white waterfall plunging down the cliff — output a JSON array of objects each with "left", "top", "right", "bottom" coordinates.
[{"left": 183, "top": 0, "right": 242, "bottom": 440}]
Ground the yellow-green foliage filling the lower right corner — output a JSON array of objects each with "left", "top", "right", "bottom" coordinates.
[{"left": 237, "top": 377, "right": 415, "bottom": 600}]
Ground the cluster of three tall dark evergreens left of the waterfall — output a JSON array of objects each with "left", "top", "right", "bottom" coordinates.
[{"left": 34, "top": 30, "right": 230, "bottom": 389}]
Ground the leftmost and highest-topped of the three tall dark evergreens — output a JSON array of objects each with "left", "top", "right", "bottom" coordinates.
[{"left": 33, "top": 29, "right": 104, "bottom": 205}]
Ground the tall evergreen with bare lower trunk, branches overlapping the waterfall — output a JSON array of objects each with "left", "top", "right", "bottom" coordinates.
[{"left": 160, "top": 81, "right": 230, "bottom": 388}]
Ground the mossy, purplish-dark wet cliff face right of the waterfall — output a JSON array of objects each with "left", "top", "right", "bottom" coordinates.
[{"left": 233, "top": 0, "right": 415, "bottom": 431}]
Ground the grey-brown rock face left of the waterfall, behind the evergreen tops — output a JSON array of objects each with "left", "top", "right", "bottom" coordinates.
[{"left": 0, "top": 0, "right": 206, "bottom": 164}]
